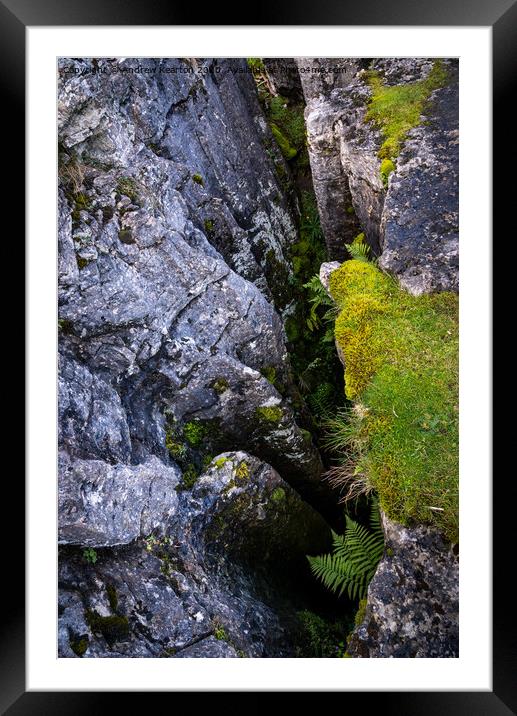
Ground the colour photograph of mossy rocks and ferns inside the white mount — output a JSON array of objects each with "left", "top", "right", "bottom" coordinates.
[{"left": 54, "top": 55, "right": 463, "bottom": 666}]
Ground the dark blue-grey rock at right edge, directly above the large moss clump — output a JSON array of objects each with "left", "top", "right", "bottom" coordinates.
[{"left": 379, "top": 64, "right": 459, "bottom": 295}]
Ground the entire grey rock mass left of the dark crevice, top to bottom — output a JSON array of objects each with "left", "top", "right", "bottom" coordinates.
[{"left": 58, "top": 59, "right": 328, "bottom": 658}]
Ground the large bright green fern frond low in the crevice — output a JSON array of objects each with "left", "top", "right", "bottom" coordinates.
[{"left": 307, "top": 498, "right": 384, "bottom": 599}]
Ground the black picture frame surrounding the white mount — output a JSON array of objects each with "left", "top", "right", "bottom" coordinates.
[{"left": 10, "top": 0, "right": 506, "bottom": 716}]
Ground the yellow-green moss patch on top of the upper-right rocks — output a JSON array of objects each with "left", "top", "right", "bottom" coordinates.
[{"left": 365, "top": 60, "right": 448, "bottom": 159}]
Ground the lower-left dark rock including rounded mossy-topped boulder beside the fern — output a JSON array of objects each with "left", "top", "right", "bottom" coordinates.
[{"left": 59, "top": 452, "right": 328, "bottom": 658}]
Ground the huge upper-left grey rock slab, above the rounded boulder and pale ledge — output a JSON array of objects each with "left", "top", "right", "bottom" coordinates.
[{"left": 59, "top": 60, "right": 322, "bottom": 489}]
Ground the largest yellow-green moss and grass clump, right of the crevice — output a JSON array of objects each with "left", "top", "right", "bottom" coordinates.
[{"left": 330, "top": 260, "right": 458, "bottom": 541}]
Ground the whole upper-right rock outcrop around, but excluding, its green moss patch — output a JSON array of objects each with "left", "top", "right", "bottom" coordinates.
[{"left": 299, "top": 59, "right": 458, "bottom": 295}]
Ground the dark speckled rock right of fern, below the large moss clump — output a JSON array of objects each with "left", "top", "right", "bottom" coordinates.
[{"left": 347, "top": 516, "right": 459, "bottom": 658}]
